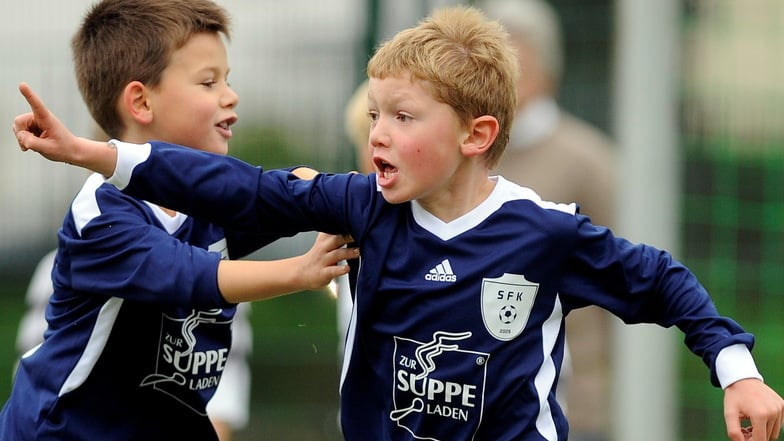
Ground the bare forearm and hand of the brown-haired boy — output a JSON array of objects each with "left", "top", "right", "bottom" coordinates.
[{"left": 218, "top": 233, "right": 359, "bottom": 303}]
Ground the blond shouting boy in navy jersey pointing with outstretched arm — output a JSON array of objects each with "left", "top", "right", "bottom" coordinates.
[{"left": 14, "top": 7, "right": 784, "bottom": 441}]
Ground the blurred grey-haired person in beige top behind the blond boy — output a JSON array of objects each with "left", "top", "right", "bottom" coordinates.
[{"left": 479, "top": 0, "right": 616, "bottom": 441}]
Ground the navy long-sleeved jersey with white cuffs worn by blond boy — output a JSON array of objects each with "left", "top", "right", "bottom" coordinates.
[{"left": 98, "top": 143, "right": 759, "bottom": 441}]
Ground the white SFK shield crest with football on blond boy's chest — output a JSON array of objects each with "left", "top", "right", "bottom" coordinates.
[{"left": 482, "top": 274, "right": 539, "bottom": 341}]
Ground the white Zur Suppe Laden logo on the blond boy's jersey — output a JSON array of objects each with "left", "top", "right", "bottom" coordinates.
[{"left": 389, "top": 331, "right": 489, "bottom": 441}]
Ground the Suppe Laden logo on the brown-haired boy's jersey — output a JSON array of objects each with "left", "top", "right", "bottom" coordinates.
[{"left": 140, "top": 309, "right": 231, "bottom": 415}]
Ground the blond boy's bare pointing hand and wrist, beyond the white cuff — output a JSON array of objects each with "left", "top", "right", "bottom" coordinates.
[{"left": 13, "top": 83, "right": 117, "bottom": 177}]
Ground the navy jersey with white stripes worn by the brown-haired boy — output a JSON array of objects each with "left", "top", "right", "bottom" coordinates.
[{"left": 0, "top": 169, "right": 276, "bottom": 441}]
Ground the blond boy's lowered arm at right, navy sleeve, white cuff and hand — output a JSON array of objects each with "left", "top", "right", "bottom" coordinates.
[{"left": 560, "top": 217, "right": 784, "bottom": 441}]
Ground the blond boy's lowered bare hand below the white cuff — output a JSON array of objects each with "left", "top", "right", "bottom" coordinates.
[{"left": 724, "top": 378, "right": 784, "bottom": 441}]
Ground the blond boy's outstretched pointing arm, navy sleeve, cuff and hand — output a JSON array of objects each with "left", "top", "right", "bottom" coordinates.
[{"left": 14, "top": 81, "right": 356, "bottom": 236}]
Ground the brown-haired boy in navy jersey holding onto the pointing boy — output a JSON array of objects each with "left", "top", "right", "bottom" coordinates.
[{"left": 0, "top": 0, "right": 355, "bottom": 441}]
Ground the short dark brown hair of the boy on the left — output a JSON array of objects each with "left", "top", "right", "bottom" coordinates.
[{"left": 71, "top": 0, "right": 230, "bottom": 137}]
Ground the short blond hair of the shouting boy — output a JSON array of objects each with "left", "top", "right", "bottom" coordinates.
[{"left": 367, "top": 6, "right": 519, "bottom": 168}]
